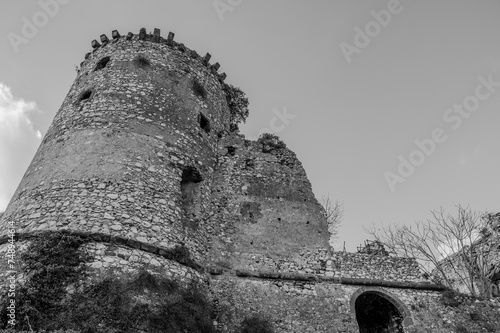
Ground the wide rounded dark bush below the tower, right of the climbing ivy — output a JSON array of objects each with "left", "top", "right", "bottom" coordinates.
[{"left": 61, "top": 271, "right": 215, "bottom": 333}]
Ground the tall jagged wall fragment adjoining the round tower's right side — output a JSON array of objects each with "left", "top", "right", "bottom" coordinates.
[{"left": 205, "top": 135, "right": 328, "bottom": 268}]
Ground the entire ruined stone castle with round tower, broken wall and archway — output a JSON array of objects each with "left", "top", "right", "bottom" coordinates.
[{"left": 0, "top": 29, "right": 498, "bottom": 333}]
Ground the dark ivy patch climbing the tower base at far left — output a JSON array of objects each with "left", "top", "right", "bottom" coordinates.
[{"left": 0, "top": 232, "right": 90, "bottom": 330}]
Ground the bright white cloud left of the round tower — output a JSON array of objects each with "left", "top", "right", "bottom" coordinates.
[{"left": 0, "top": 82, "right": 42, "bottom": 211}]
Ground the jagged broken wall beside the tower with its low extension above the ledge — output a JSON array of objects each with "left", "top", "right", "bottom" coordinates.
[{"left": 203, "top": 135, "right": 429, "bottom": 283}]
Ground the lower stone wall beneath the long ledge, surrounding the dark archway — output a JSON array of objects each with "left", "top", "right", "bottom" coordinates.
[{"left": 211, "top": 276, "right": 500, "bottom": 333}]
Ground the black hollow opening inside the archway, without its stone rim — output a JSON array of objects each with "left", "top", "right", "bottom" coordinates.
[{"left": 355, "top": 292, "right": 404, "bottom": 333}]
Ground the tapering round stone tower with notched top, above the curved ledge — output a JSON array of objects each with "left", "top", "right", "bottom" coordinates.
[{"left": 0, "top": 28, "right": 230, "bottom": 260}]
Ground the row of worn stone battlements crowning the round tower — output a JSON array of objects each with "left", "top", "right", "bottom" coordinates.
[{"left": 85, "top": 28, "right": 227, "bottom": 84}]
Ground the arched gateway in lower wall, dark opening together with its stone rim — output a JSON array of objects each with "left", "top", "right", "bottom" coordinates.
[{"left": 351, "top": 287, "right": 413, "bottom": 333}]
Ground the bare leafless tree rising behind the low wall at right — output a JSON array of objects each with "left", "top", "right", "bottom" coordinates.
[{"left": 365, "top": 205, "right": 491, "bottom": 297}]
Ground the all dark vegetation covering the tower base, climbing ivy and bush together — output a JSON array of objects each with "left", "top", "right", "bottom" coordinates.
[{"left": 0, "top": 233, "right": 215, "bottom": 333}]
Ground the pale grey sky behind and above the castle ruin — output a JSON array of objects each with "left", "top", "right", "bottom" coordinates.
[{"left": 0, "top": 0, "right": 500, "bottom": 251}]
